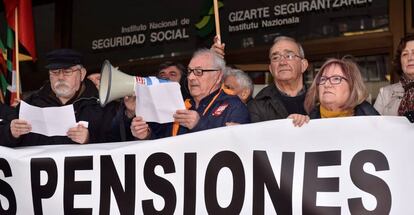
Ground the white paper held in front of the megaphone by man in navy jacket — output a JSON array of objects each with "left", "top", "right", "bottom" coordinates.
[{"left": 135, "top": 79, "right": 185, "bottom": 123}]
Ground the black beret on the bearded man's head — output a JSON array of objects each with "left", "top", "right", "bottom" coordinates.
[{"left": 46, "top": 49, "right": 83, "bottom": 69}]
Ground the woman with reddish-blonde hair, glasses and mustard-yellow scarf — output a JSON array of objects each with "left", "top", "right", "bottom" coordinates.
[{"left": 304, "top": 58, "right": 379, "bottom": 119}]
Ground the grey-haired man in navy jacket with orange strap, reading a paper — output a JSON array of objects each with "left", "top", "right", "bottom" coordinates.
[{"left": 130, "top": 49, "right": 250, "bottom": 139}]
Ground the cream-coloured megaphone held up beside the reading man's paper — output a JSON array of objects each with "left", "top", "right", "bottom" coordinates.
[{"left": 99, "top": 60, "right": 136, "bottom": 107}]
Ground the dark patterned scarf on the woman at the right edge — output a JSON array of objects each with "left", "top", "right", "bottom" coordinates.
[{"left": 398, "top": 75, "right": 414, "bottom": 116}]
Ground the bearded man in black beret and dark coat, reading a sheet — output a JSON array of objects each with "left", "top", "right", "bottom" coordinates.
[{"left": 3, "top": 49, "right": 110, "bottom": 146}]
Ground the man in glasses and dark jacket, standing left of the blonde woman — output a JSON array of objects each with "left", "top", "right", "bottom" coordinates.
[{"left": 248, "top": 36, "right": 309, "bottom": 126}]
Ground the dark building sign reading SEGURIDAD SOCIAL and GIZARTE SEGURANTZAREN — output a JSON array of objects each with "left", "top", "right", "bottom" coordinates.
[{"left": 72, "top": 0, "right": 388, "bottom": 68}]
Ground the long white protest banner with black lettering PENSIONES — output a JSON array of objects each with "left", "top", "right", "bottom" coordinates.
[{"left": 0, "top": 116, "right": 414, "bottom": 215}]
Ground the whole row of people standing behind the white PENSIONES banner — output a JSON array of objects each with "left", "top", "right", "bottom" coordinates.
[{"left": 0, "top": 35, "right": 414, "bottom": 147}]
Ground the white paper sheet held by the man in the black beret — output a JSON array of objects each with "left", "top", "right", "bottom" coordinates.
[{"left": 19, "top": 101, "right": 76, "bottom": 137}]
